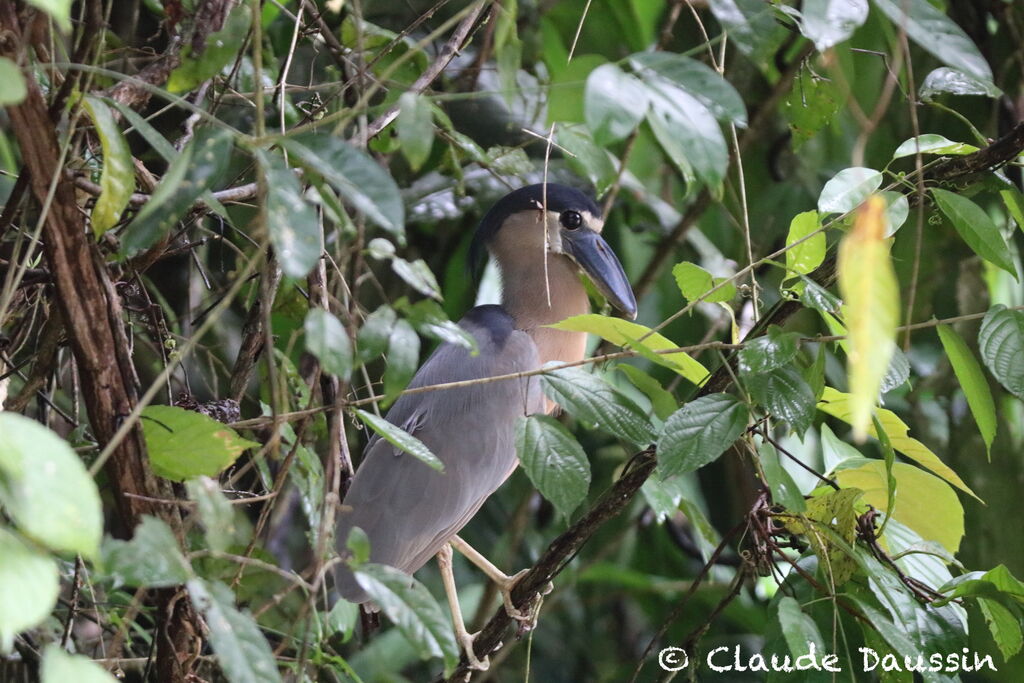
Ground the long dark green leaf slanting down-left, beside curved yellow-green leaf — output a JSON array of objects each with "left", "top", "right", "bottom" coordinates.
[{"left": 121, "top": 128, "right": 233, "bottom": 257}]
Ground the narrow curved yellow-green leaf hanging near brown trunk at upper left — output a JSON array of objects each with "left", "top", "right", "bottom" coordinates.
[{"left": 82, "top": 95, "right": 135, "bottom": 238}]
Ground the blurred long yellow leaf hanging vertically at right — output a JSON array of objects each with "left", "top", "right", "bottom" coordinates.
[{"left": 837, "top": 195, "right": 899, "bottom": 441}]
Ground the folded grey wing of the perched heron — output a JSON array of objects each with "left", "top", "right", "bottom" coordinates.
[{"left": 336, "top": 309, "right": 543, "bottom": 601}]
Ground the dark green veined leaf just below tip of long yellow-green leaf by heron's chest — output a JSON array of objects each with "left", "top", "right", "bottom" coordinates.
[{"left": 657, "top": 393, "right": 750, "bottom": 479}]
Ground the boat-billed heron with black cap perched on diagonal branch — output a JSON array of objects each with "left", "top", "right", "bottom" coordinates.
[{"left": 336, "top": 183, "right": 636, "bottom": 668}]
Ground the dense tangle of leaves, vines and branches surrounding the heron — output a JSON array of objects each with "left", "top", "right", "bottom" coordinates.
[{"left": 0, "top": 0, "right": 1024, "bottom": 682}]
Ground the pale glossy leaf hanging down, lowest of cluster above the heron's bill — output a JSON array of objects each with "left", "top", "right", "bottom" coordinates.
[{"left": 641, "top": 72, "right": 729, "bottom": 187}]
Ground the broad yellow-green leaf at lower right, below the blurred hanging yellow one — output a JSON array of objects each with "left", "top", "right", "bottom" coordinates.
[{"left": 836, "top": 460, "right": 964, "bottom": 553}]
